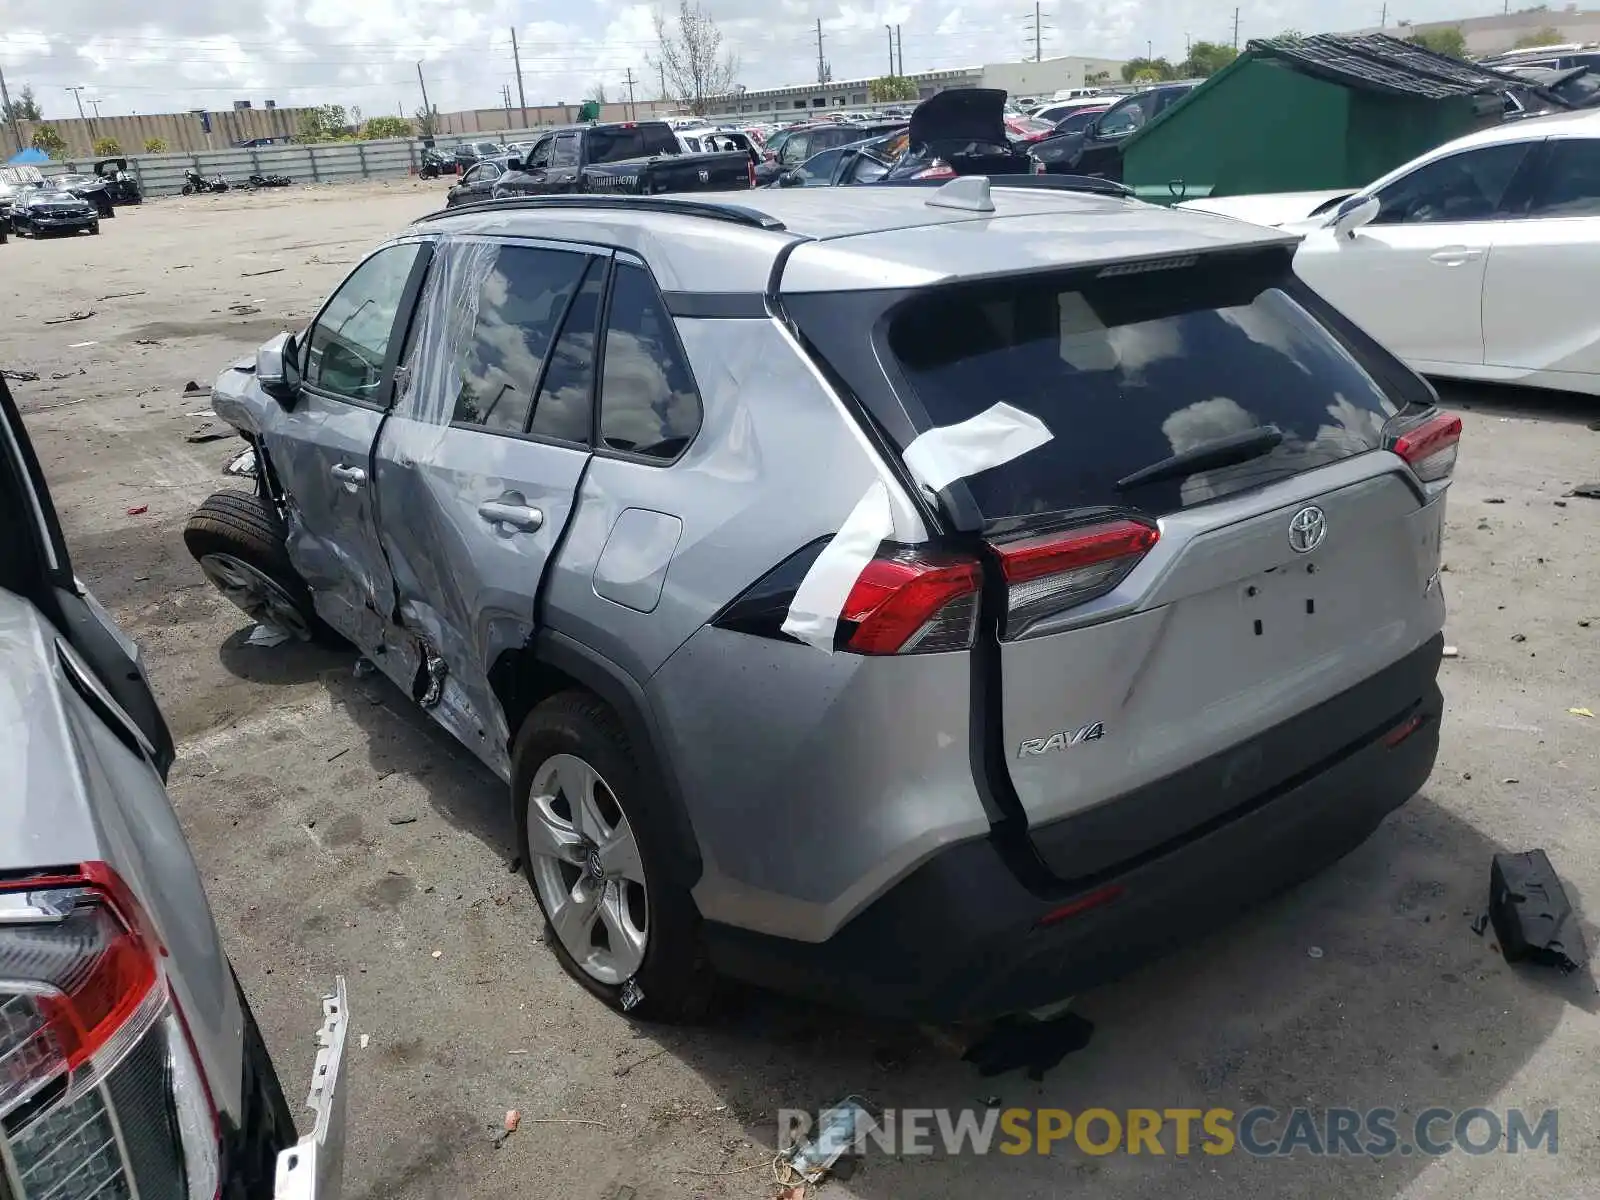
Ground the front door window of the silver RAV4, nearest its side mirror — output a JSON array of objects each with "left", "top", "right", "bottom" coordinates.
[{"left": 304, "top": 242, "right": 421, "bottom": 403}]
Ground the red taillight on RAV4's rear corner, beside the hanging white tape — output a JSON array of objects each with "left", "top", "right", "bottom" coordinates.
[{"left": 840, "top": 554, "right": 982, "bottom": 654}]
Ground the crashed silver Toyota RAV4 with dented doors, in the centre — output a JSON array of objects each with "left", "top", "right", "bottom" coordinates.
[{"left": 186, "top": 178, "right": 1461, "bottom": 1019}]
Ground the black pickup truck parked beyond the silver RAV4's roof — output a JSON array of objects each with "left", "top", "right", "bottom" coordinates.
[{"left": 493, "top": 122, "right": 755, "bottom": 200}]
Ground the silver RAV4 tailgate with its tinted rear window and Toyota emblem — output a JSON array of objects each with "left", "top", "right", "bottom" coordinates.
[{"left": 825, "top": 248, "right": 1443, "bottom": 880}]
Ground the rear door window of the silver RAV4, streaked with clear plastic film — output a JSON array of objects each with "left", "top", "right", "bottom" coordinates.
[{"left": 448, "top": 242, "right": 589, "bottom": 434}]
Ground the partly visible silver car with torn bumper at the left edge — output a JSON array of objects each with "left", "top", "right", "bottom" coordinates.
[{"left": 0, "top": 378, "right": 347, "bottom": 1200}]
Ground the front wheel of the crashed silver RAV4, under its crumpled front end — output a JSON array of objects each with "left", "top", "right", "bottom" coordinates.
[{"left": 184, "top": 491, "right": 341, "bottom": 645}]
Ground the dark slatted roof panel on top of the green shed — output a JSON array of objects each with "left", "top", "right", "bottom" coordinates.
[{"left": 1245, "top": 34, "right": 1528, "bottom": 99}]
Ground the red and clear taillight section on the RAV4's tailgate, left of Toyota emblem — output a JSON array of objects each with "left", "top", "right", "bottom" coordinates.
[{"left": 994, "top": 520, "right": 1162, "bottom": 637}]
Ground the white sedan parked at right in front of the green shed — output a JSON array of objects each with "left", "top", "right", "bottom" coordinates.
[{"left": 1182, "top": 110, "right": 1600, "bottom": 395}]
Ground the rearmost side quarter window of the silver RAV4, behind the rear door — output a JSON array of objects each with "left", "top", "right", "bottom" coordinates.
[{"left": 600, "top": 262, "right": 701, "bottom": 459}]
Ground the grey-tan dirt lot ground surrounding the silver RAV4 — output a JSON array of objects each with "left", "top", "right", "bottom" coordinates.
[{"left": 0, "top": 181, "right": 1600, "bottom": 1200}]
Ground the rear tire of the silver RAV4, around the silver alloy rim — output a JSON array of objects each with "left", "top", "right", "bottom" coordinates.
[{"left": 512, "top": 691, "right": 715, "bottom": 1022}]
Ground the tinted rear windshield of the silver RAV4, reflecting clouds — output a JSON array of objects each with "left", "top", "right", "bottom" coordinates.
[{"left": 888, "top": 266, "right": 1398, "bottom": 522}]
